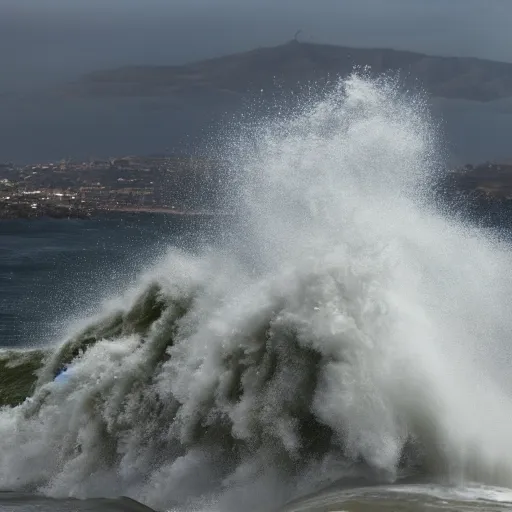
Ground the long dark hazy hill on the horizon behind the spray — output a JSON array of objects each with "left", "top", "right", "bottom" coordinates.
[{"left": 67, "top": 41, "right": 512, "bottom": 102}]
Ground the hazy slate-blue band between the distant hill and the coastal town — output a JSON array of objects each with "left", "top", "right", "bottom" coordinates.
[{"left": 0, "top": 93, "right": 512, "bottom": 165}]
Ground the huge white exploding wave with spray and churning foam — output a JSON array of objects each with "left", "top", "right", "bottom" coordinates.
[{"left": 0, "top": 75, "right": 512, "bottom": 510}]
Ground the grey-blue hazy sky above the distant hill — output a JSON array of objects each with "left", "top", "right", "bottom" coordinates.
[{"left": 0, "top": 0, "right": 512, "bottom": 92}]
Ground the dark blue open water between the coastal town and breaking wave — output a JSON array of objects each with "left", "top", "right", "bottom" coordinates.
[{"left": 0, "top": 214, "right": 217, "bottom": 347}]
